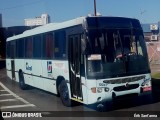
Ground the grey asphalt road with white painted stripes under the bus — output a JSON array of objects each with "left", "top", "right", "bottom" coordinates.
[{"left": 0, "top": 69, "right": 160, "bottom": 120}]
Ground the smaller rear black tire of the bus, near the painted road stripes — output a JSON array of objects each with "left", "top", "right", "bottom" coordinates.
[{"left": 19, "top": 71, "right": 27, "bottom": 90}]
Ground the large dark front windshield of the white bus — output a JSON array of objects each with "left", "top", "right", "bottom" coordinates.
[{"left": 86, "top": 28, "right": 150, "bottom": 79}]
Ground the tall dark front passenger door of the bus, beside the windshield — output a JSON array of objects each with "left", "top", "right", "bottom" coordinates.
[{"left": 68, "top": 35, "right": 83, "bottom": 101}]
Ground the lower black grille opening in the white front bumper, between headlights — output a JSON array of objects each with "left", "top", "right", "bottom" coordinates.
[{"left": 113, "top": 84, "right": 139, "bottom": 92}]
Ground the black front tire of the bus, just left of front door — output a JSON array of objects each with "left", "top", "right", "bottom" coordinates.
[{"left": 58, "top": 80, "right": 72, "bottom": 107}]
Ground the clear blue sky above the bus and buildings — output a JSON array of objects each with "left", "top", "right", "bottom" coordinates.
[{"left": 0, "top": 0, "right": 160, "bottom": 27}]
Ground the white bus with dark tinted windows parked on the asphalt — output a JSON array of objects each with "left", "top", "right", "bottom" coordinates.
[{"left": 6, "top": 16, "right": 152, "bottom": 109}]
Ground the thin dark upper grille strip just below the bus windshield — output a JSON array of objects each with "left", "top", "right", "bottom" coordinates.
[{"left": 103, "top": 75, "right": 145, "bottom": 84}]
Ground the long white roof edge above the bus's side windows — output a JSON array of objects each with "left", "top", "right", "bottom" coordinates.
[{"left": 7, "top": 17, "right": 85, "bottom": 41}]
